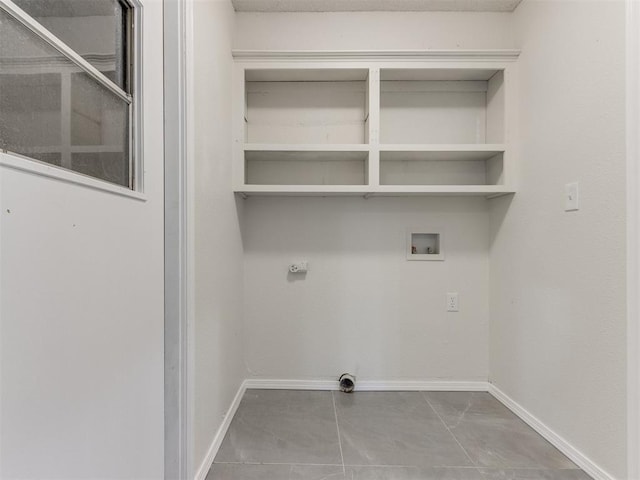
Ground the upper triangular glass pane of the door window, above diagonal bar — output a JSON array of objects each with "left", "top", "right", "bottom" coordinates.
[{"left": 13, "top": 0, "right": 130, "bottom": 93}]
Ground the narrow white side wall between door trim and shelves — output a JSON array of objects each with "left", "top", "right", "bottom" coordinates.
[{"left": 188, "top": 0, "right": 246, "bottom": 470}]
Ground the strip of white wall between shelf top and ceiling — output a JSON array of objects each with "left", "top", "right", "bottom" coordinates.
[{"left": 233, "top": 12, "right": 513, "bottom": 50}]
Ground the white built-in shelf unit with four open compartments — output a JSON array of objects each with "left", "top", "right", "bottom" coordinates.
[{"left": 234, "top": 51, "right": 517, "bottom": 197}]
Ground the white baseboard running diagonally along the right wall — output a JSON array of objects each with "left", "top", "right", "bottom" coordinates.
[{"left": 489, "top": 384, "right": 615, "bottom": 480}]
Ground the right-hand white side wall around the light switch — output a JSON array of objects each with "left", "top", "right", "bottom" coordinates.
[{"left": 490, "top": 0, "right": 626, "bottom": 478}]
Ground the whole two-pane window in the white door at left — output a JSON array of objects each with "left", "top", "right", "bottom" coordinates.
[{"left": 0, "top": 0, "right": 139, "bottom": 189}]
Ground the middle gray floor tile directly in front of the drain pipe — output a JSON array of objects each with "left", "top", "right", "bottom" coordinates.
[{"left": 336, "top": 392, "right": 473, "bottom": 467}]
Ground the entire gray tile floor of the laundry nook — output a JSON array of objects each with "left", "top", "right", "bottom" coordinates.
[{"left": 206, "top": 390, "right": 590, "bottom": 480}]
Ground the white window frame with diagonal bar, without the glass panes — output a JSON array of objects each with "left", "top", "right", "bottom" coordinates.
[{"left": 0, "top": 0, "right": 144, "bottom": 192}]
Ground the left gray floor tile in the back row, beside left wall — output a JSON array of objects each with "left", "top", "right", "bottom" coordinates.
[{"left": 215, "top": 390, "right": 342, "bottom": 465}]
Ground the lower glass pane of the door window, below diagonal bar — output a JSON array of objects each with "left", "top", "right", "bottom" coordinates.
[{"left": 0, "top": 9, "right": 130, "bottom": 187}]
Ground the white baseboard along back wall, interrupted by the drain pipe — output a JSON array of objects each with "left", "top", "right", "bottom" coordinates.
[{"left": 244, "top": 378, "right": 489, "bottom": 392}]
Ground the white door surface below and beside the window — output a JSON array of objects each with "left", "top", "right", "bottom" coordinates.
[{"left": 0, "top": 1, "right": 164, "bottom": 479}]
